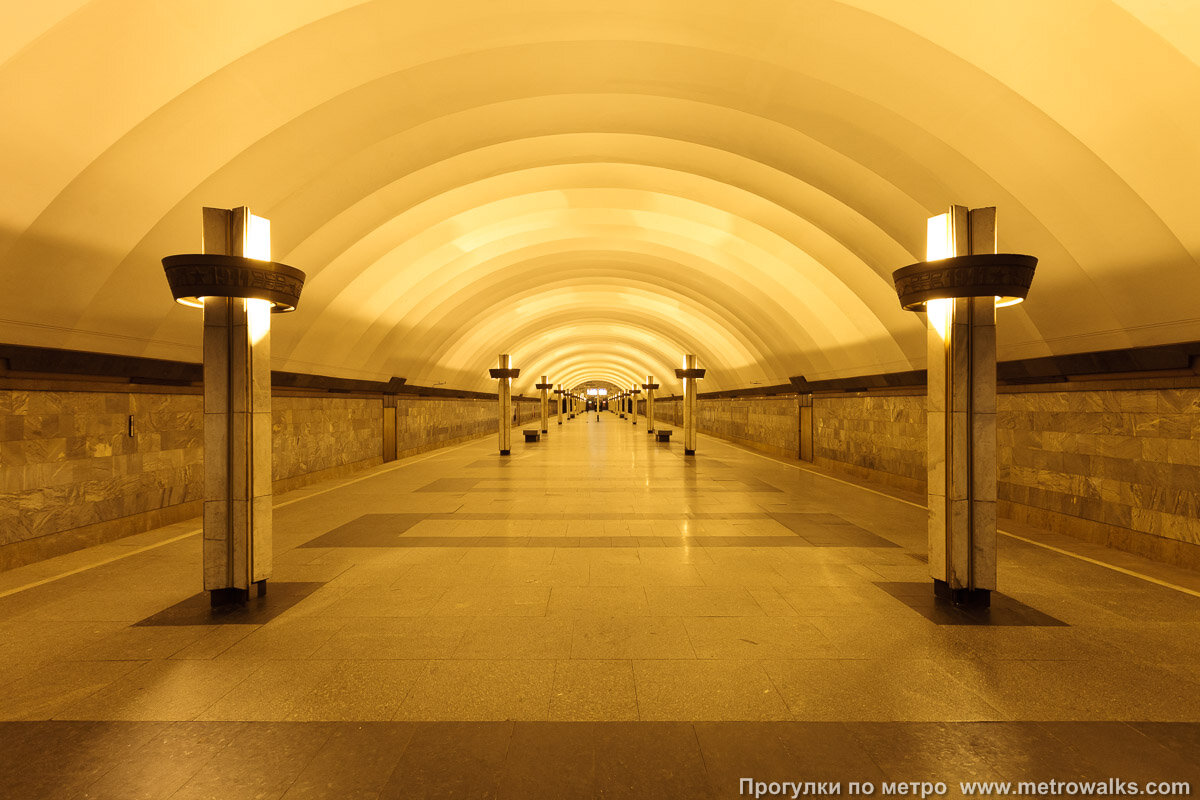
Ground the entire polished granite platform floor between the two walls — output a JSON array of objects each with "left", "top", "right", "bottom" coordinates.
[{"left": 0, "top": 414, "right": 1200, "bottom": 800}]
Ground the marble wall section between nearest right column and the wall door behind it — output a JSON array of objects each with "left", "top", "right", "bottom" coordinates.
[{"left": 812, "top": 393, "right": 926, "bottom": 492}]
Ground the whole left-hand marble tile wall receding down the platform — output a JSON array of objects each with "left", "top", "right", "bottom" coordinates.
[{"left": 0, "top": 390, "right": 540, "bottom": 570}]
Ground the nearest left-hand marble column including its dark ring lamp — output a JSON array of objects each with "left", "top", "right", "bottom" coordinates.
[{"left": 162, "top": 206, "right": 305, "bottom": 607}]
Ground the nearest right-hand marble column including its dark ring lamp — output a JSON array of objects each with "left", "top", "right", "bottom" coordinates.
[{"left": 893, "top": 205, "right": 1038, "bottom": 607}]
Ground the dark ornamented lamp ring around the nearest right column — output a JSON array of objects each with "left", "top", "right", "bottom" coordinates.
[{"left": 892, "top": 253, "right": 1038, "bottom": 311}]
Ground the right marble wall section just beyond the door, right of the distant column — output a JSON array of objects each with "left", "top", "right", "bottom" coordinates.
[{"left": 696, "top": 395, "right": 800, "bottom": 458}]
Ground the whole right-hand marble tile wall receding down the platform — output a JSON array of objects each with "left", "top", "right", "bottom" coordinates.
[{"left": 672, "top": 386, "right": 1200, "bottom": 569}]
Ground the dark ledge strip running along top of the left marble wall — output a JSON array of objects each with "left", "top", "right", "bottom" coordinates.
[{"left": 0, "top": 344, "right": 534, "bottom": 401}]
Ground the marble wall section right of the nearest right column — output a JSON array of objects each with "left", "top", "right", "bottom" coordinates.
[{"left": 997, "top": 389, "right": 1200, "bottom": 567}]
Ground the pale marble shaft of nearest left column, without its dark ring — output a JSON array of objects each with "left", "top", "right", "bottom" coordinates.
[{"left": 202, "top": 207, "right": 272, "bottom": 606}]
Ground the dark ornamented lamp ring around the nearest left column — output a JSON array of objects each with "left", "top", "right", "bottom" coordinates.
[{"left": 162, "top": 253, "right": 305, "bottom": 313}]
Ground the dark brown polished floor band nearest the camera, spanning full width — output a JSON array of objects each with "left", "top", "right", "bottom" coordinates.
[{"left": 0, "top": 722, "right": 1200, "bottom": 800}]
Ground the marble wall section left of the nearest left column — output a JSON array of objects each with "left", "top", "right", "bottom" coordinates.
[{"left": 0, "top": 390, "right": 204, "bottom": 554}]
